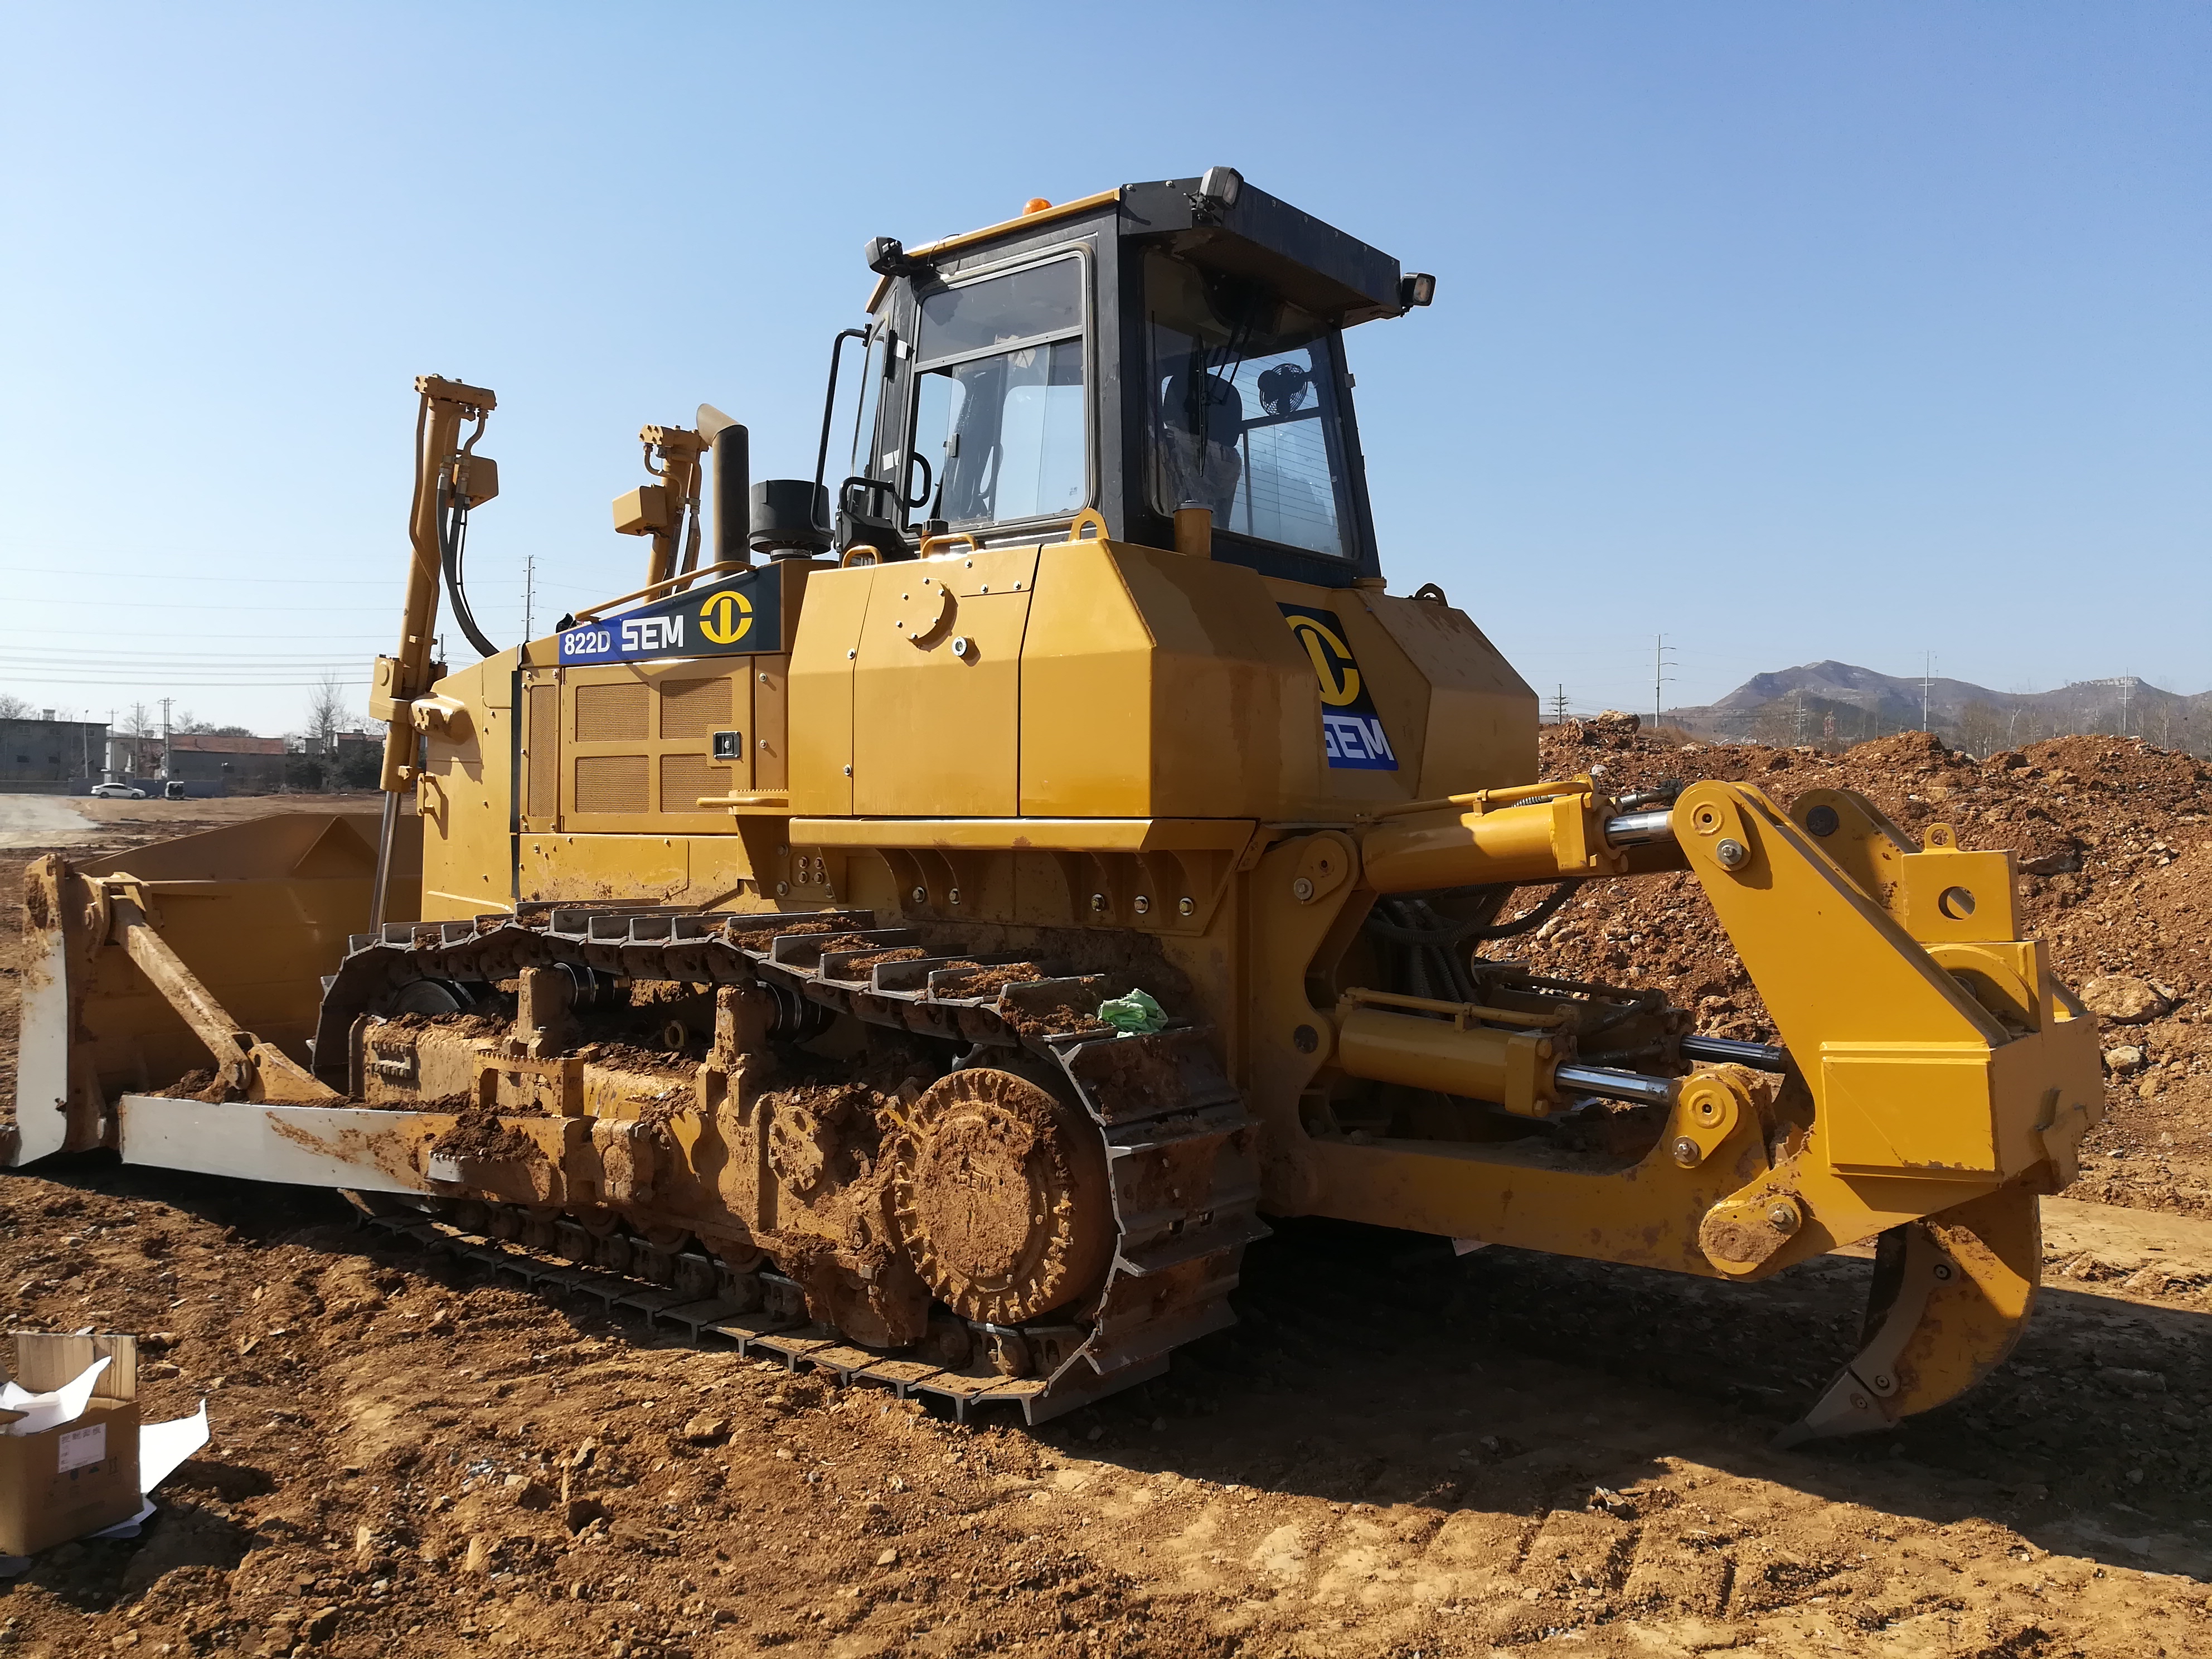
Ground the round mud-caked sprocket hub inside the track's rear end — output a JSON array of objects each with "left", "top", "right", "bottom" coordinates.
[{"left": 891, "top": 1066, "right": 1115, "bottom": 1325}]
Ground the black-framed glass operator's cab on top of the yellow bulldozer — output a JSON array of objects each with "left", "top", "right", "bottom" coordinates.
[{"left": 836, "top": 168, "right": 1433, "bottom": 586}]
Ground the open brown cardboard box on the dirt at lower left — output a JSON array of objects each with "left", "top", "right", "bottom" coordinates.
[{"left": 0, "top": 1332, "right": 139, "bottom": 1555}]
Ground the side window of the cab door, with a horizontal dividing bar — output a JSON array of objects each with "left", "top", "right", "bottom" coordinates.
[{"left": 914, "top": 256, "right": 1090, "bottom": 524}]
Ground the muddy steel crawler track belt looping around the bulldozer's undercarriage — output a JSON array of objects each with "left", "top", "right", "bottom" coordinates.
[{"left": 314, "top": 907, "right": 1268, "bottom": 1422}]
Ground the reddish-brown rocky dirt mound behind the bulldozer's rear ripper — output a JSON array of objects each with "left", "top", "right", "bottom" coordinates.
[{"left": 1530, "top": 724, "right": 2212, "bottom": 1214}]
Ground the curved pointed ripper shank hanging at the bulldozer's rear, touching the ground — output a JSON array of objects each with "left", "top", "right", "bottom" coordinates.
[{"left": 1776, "top": 1183, "right": 2044, "bottom": 1447}]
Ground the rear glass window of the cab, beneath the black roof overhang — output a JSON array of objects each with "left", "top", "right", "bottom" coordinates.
[{"left": 1143, "top": 252, "right": 1347, "bottom": 557}]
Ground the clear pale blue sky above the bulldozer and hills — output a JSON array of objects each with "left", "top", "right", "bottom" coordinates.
[{"left": 0, "top": 0, "right": 2212, "bottom": 730}]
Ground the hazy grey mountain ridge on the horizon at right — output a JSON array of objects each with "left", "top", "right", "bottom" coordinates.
[{"left": 1663, "top": 661, "right": 2212, "bottom": 754}]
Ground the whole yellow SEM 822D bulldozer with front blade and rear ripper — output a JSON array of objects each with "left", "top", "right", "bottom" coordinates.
[{"left": 7, "top": 168, "right": 2102, "bottom": 1438}]
